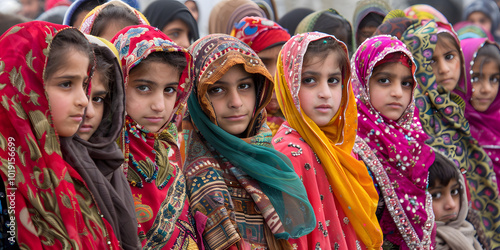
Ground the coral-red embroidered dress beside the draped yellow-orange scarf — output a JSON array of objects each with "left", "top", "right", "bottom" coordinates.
[{"left": 273, "top": 122, "right": 365, "bottom": 249}]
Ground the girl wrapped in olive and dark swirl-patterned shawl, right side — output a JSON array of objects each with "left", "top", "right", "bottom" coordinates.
[{"left": 401, "top": 21, "right": 500, "bottom": 248}]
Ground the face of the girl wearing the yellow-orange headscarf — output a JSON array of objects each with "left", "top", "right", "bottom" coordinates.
[{"left": 299, "top": 52, "right": 342, "bottom": 127}]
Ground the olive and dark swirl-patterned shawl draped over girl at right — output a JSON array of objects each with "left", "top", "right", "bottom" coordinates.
[{"left": 402, "top": 21, "right": 500, "bottom": 250}]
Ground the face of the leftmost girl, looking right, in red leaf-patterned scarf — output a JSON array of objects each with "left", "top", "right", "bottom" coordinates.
[{"left": 45, "top": 49, "right": 89, "bottom": 137}]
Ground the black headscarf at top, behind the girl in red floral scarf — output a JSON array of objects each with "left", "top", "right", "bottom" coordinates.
[{"left": 143, "top": 0, "right": 200, "bottom": 43}]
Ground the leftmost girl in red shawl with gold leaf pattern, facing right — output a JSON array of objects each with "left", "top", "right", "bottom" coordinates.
[{"left": 0, "top": 22, "right": 120, "bottom": 249}]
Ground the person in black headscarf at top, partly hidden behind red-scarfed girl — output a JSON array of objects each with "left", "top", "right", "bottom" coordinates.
[{"left": 144, "top": 0, "right": 200, "bottom": 48}]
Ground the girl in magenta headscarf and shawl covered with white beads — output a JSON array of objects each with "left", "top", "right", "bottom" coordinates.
[{"left": 351, "top": 35, "right": 434, "bottom": 249}]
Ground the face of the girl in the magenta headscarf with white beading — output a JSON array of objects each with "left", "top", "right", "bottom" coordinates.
[{"left": 368, "top": 62, "right": 415, "bottom": 121}]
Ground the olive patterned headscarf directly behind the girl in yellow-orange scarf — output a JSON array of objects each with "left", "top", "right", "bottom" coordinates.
[{"left": 295, "top": 8, "right": 356, "bottom": 53}]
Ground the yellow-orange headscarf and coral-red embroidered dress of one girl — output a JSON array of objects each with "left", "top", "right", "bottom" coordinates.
[{"left": 273, "top": 32, "right": 383, "bottom": 249}]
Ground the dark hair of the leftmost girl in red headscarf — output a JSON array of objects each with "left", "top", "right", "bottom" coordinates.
[{"left": 43, "top": 28, "right": 94, "bottom": 81}]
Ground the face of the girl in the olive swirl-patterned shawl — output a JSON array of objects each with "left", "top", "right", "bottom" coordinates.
[{"left": 431, "top": 38, "right": 462, "bottom": 92}]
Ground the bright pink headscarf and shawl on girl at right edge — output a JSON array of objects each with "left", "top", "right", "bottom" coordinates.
[{"left": 459, "top": 38, "right": 500, "bottom": 190}]
